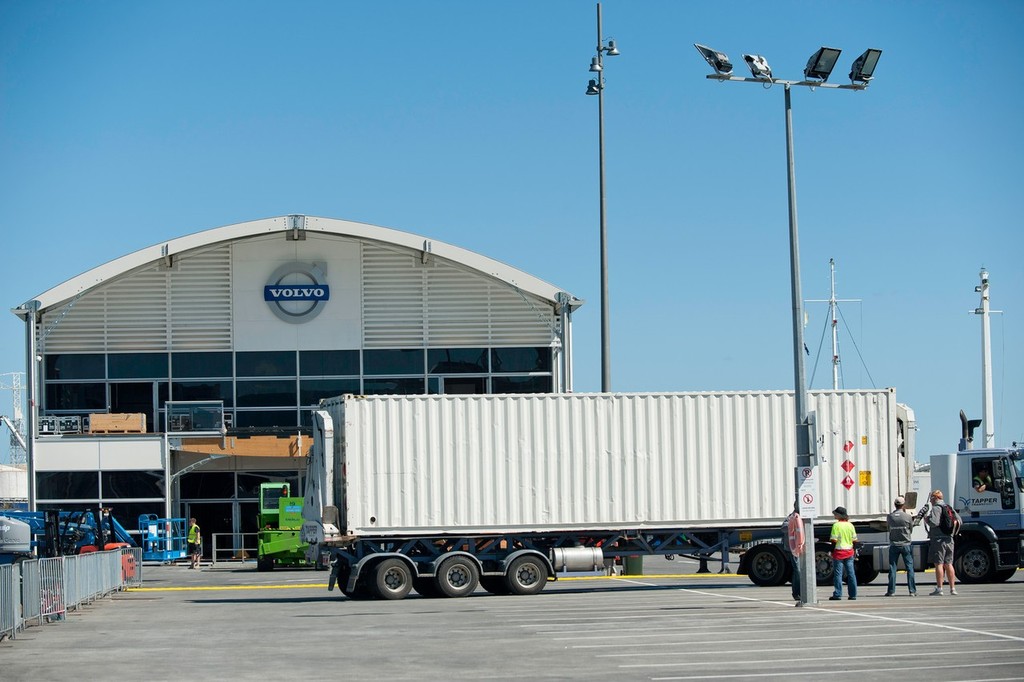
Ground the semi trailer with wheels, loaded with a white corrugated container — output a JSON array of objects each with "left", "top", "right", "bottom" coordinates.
[{"left": 301, "top": 389, "right": 914, "bottom": 599}]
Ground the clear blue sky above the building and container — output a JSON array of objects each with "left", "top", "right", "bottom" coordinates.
[{"left": 0, "top": 0, "right": 1024, "bottom": 460}]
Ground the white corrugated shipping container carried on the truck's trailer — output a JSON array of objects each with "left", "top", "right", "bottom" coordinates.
[{"left": 326, "top": 389, "right": 912, "bottom": 535}]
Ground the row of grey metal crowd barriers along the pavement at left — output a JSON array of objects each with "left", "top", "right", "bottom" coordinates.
[{"left": 0, "top": 547, "right": 142, "bottom": 639}]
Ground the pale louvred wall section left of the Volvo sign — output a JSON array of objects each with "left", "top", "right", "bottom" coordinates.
[{"left": 39, "top": 246, "right": 231, "bottom": 353}]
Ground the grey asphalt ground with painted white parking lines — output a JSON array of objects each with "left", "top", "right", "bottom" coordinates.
[{"left": 0, "top": 558, "right": 1024, "bottom": 682}]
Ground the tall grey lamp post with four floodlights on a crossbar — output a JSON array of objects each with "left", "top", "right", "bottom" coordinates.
[{"left": 694, "top": 44, "right": 882, "bottom": 604}]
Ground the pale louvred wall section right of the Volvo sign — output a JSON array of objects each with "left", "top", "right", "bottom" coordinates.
[{"left": 362, "top": 245, "right": 558, "bottom": 348}]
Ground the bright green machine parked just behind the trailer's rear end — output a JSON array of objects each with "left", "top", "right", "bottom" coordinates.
[{"left": 256, "top": 483, "right": 311, "bottom": 570}]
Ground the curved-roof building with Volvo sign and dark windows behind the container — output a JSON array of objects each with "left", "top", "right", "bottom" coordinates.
[{"left": 13, "top": 215, "right": 582, "bottom": 532}]
